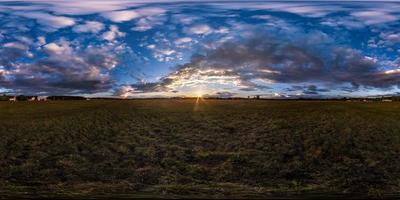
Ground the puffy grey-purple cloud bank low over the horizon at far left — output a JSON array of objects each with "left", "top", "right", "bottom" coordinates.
[{"left": 0, "top": 39, "right": 118, "bottom": 94}]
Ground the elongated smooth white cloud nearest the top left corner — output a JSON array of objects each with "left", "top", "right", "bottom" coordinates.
[{"left": 16, "top": 12, "right": 75, "bottom": 30}]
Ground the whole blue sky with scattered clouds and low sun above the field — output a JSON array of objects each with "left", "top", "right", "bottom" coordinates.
[{"left": 0, "top": 0, "right": 400, "bottom": 98}]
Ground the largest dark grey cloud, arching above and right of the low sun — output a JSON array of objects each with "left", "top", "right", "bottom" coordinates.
[{"left": 133, "top": 32, "right": 400, "bottom": 94}]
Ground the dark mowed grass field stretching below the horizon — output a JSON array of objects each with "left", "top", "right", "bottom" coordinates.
[{"left": 0, "top": 100, "right": 400, "bottom": 198}]
